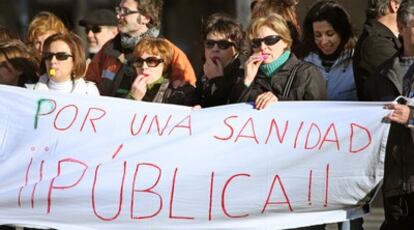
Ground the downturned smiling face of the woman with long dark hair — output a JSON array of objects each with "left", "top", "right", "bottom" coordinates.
[{"left": 312, "top": 21, "right": 341, "bottom": 55}]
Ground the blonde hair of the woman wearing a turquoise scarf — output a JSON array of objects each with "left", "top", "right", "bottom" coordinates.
[{"left": 248, "top": 14, "right": 293, "bottom": 49}]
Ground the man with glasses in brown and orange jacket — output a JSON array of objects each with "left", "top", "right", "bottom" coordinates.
[{"left": 86, "top": 0, "right": 196, "bottom": 98}]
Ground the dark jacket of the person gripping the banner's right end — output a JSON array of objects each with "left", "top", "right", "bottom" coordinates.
[{"left": 365, "top": 55, "right": 414, "bottom": 197}]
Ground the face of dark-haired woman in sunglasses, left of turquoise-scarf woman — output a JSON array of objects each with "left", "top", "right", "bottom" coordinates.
[{"left": 204, "top": 33, "right": 237, "bottom": 67}]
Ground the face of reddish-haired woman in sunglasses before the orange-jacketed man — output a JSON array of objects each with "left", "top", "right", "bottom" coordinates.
[{"left": 134, "top": 52, "right": 164, "bottom": 84}]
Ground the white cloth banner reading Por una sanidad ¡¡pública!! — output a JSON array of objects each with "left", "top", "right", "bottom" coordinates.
[{"left": 0, "top": 86, "right": 389, "bottom": 229}]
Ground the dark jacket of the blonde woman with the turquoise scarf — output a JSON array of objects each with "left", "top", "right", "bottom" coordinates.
[{"left": 230, "top": 54, "right": 326, "bottom": 103}]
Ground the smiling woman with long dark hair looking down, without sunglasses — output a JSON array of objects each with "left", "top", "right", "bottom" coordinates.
[{"left": 303, "top": 0, "right": 358, "bottom": 101}]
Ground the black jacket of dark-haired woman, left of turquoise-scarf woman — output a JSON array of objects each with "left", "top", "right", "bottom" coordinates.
[{"left": 197, "top": 58, "right": 243, "bottom": 108}]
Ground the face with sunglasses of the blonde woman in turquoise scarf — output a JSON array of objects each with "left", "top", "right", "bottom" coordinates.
[{"left": 251, "top": 26, "right": 287, "bottom": 64}]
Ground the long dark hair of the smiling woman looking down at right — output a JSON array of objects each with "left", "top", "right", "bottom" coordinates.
[{"left": 303, "top": 0, "right": 356, "bottom": 55}]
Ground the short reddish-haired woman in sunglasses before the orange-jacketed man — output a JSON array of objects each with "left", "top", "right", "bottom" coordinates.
[{"left": 128, "top": 37, "right": 195, "bottom": 106}]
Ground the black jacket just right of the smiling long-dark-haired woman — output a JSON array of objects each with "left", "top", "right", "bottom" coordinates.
[{"left": 353, "top": 19, "right": 401, "bottom": 101}]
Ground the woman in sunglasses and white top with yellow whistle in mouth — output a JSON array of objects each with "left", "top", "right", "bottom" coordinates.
[{"left": 28, "top": 33, "right": 99, "bottom": 95}]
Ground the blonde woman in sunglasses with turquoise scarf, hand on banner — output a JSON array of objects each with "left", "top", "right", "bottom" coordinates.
[{"left": 231, "top": 14, "right": 326, "bottom": 109}]
